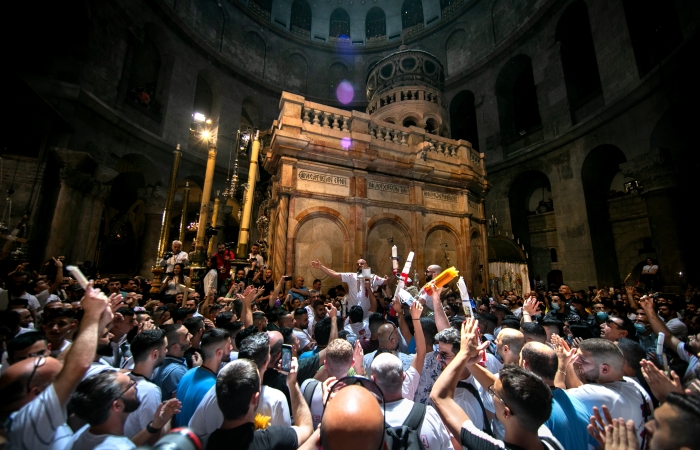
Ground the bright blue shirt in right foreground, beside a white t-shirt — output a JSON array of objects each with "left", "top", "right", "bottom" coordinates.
[{"left": 544, "top": 389, "right": 590, "bottom": 450}]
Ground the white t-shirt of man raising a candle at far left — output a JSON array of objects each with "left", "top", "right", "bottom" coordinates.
[{"left": 7, "top": 384, "right": 73, "bottom": 450}]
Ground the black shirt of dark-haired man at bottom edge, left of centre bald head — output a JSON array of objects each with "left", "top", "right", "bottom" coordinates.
[{"left": 207, "top": 423, "right": 298, "bottom": 450}]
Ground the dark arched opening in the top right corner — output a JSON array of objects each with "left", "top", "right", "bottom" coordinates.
[{"left": 622, "top": 0, "right": 683, "bottom": 78}]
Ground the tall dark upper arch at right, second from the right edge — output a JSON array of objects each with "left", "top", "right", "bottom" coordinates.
[{"left": 555, "top": 0, "right": 604, "bottom": 124}]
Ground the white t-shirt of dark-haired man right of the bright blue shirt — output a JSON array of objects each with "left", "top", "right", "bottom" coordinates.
[{"left": 566, "top": 377, "right": 654, "bottom": 443}]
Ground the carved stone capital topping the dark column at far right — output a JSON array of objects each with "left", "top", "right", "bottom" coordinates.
[{"left": 620, "top": 148, "right": 678, "bottom": 194}]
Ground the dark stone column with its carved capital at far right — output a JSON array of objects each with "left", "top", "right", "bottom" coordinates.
[{"left": 620, "top": 149, "right": 688, "bottom": 290}]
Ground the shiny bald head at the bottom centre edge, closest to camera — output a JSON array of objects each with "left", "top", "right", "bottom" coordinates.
[{"left": 321, "top": 386, "right": 384, "bottom": 450}]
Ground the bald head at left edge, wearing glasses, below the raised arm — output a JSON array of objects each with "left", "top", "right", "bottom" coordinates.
[{"left": 0, "top": 357, "right": 63, "bottom": 414}]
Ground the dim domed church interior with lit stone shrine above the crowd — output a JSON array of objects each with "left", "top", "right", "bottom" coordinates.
[{"left": 0, "top": 0, "right": 700, "bottom": 293}]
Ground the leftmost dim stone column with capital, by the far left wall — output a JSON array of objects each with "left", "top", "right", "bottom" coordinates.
[{"left": 44, "top": 165, "right": 93, "bottom": 262}]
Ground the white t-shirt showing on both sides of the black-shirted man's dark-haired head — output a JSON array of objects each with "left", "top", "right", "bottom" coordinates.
[{"left": 189, "top": 385, "right": 292, "bottom": 448}]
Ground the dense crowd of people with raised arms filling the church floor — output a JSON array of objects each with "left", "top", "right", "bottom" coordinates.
[{"left": 0, "top": 241, "right": 700, "bottom": 450}]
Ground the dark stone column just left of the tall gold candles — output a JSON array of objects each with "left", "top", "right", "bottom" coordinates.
[{"left": 138, "top": 186, "right": 168, "bottom": 278}]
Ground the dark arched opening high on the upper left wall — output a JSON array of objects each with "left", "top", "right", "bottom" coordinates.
[{"left": 126, "top": 36, "right": 161, "bottom": 115}]
